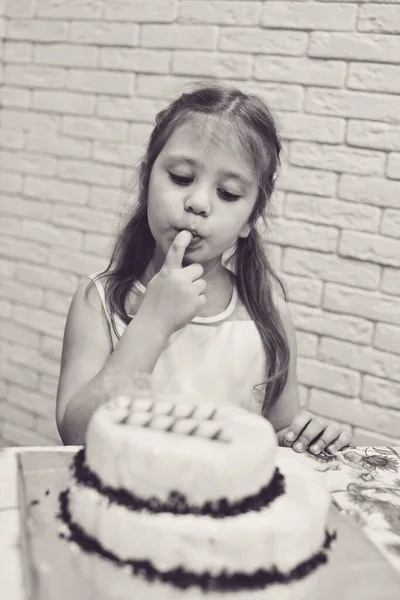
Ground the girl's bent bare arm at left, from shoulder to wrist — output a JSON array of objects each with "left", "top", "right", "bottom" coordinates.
[{"left": 56, "top": 280, "right": 168, "bottom": 444}]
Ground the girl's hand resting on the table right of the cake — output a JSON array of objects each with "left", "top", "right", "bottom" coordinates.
[{"left": 279, "top": 410, "right": 351, "bottom": 454}]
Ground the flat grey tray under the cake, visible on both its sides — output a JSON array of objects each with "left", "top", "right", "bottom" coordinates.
[{"left": 18, "top": 451, "right": 400, "bottom": 600}]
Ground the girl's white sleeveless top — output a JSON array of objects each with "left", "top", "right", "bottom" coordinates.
[{"left": 90, "top": 273, "right": 267, "bottom": 413}]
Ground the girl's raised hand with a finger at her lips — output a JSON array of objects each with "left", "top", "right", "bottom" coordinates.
[{"left": 140, "top": 230, "right": 207, "bottom": 336}]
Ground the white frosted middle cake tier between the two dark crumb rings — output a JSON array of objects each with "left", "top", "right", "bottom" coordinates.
[{"left": 70, "top": 454, "right": 330, "bottom": 574}]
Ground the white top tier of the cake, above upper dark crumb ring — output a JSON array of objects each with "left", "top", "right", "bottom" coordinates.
[{"left": 86, "top": 394, "right": 277, "bottom": 504}]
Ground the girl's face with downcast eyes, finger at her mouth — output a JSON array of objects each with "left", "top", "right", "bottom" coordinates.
[{"left": 147, "top": 119, "right": 258, "bottom": 270}]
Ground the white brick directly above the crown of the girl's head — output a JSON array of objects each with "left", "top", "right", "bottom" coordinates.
[{"left": 171, "top": 51, "right": 251, "bottom": 79}]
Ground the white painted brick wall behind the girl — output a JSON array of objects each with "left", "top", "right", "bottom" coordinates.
[{"left": 0, "top": 0, "right": 400, "bottom": 445}]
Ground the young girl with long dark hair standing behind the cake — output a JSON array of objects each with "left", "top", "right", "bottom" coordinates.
[{"left": 57, "top": 84, "right": 350, "bottom": 454}]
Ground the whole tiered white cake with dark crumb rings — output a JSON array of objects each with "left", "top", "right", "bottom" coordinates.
[{"left": 60, "top": 394, "right": 334, "bottom": 600}]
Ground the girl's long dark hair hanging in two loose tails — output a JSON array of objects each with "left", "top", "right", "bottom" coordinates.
[{"left": 90, "top": 83, "right": 290, "bottom": 415}]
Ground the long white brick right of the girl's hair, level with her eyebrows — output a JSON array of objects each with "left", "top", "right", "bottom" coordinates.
[{"left": 289, "top": 142, "right": 386, "bottom": 175}]
